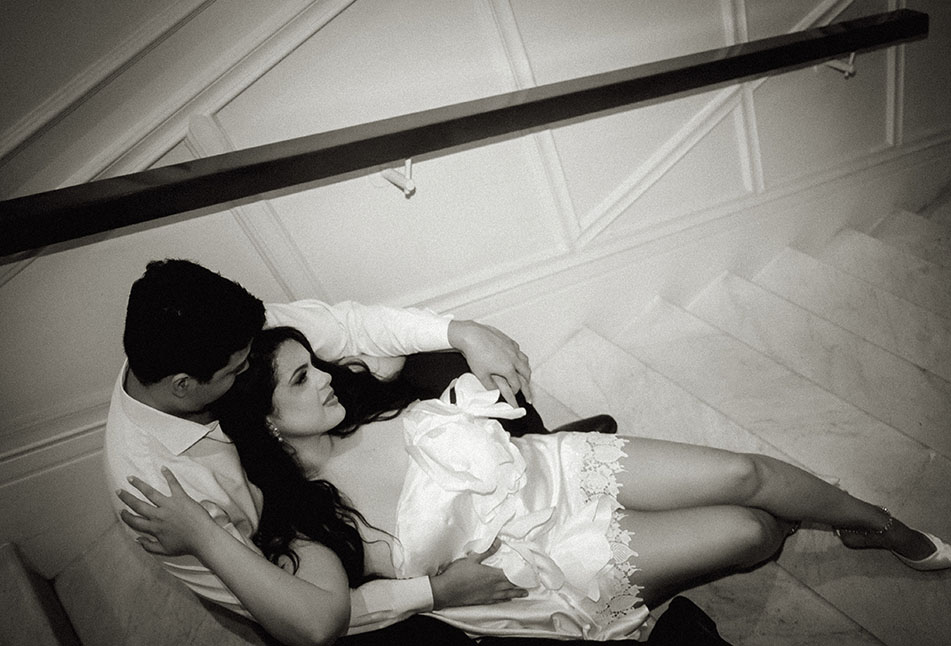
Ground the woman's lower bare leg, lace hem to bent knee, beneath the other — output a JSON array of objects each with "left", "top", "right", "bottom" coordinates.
[{"left": 621, "top": 505, "right": 790, "bottom": 608}]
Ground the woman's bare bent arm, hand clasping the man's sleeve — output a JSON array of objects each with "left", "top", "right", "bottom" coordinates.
[{"left": 118, "top": 469, "right": 350, "bottom": 645}]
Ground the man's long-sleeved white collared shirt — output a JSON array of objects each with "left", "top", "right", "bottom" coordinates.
[{"left": 104, "top": 300, "right": 451, "bottom": 634}]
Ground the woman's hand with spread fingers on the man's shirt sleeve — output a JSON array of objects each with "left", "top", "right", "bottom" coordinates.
[{"left": 116, "top": 467, "right": 223, "bottom": 556}]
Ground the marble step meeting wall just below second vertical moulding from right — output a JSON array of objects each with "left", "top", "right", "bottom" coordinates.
[{"left": 753, "top": 248, "right": 951, "bottom": 380}]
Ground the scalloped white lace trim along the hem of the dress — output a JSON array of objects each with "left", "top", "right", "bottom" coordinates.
[{"left": 581, "top": 433, "right": 644, "bottom": 625}]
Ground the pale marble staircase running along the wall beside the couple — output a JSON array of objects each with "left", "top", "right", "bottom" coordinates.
[{"left": 534, "top": 209, "right": 951, "bottom": 646}]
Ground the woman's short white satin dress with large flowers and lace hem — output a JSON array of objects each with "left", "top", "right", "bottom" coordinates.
[{"left": 367, "top": 375, "right": 649, "bottom": 640}]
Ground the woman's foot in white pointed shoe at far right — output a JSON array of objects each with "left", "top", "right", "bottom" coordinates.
[{"left": 836, "top": 509, "right": 951, "bottom": 570}]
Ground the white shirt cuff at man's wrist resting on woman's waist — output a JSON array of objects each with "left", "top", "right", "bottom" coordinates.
[{"left": 347, "top": 576, "right": 433, "bottom": 635}]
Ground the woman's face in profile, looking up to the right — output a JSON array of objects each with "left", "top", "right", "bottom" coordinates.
[{"left": 268, "top": 340, "right": 346, "bottom": 438}]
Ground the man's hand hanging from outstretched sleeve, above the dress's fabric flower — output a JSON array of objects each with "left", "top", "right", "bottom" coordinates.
[{"left": 449, "top": 320, "right": 532, "bottom": 407}]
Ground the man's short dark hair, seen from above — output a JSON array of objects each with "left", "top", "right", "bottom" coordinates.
[{"left": 122, "top": 260, "right": 264, "bottom": 384}]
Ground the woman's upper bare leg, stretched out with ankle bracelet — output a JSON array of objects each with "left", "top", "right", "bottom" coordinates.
[{"left": 617, "top": 437, "right": 934, "bottom": 559}]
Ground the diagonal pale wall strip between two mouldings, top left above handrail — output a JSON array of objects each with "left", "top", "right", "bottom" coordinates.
[{"left": 0, "top": 0, "right": 309, "bottom": 197}]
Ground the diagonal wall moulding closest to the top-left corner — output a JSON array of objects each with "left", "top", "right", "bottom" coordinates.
[{"left": 0, "top": 0, "right": 215, "bottom": 163}]
